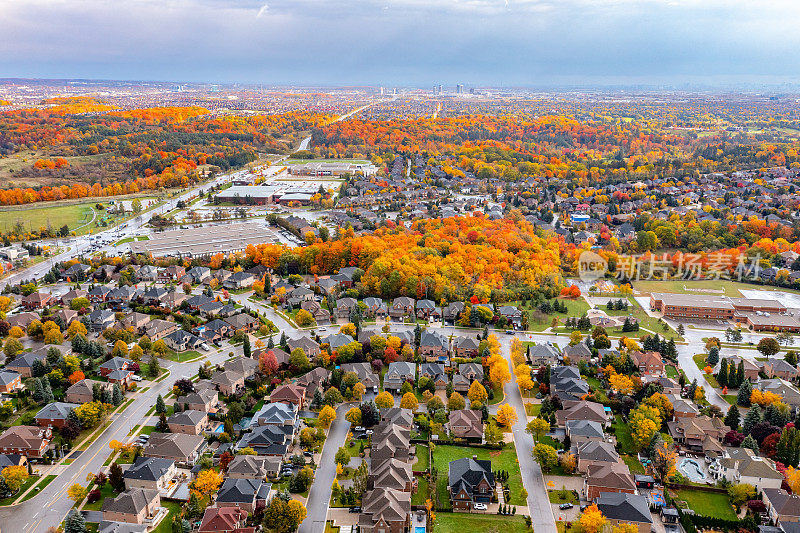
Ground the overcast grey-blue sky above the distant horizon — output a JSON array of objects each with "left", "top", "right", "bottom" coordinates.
[{"left": 0, "top": 0, "right": 800, "bottom": 87}]
